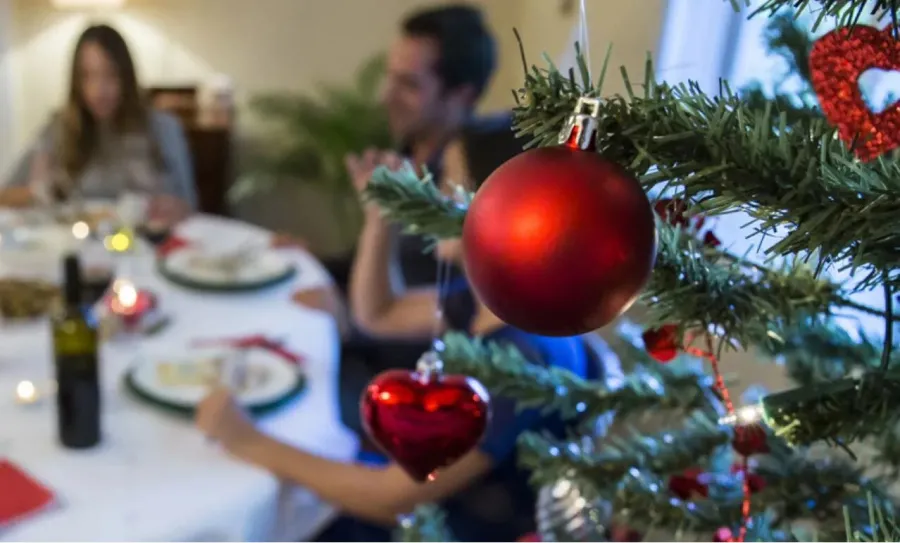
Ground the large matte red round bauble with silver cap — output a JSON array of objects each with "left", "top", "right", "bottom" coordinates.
[{"left": 462, "top": 99, "right": 656, "bottom": 336}]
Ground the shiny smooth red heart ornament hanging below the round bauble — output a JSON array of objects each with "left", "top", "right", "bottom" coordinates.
[{"left": 360, "top": 370, "right": 490, "bottom": 481}]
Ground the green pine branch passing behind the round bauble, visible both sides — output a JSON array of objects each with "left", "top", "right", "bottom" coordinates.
[{"left": 366, "top": 168, "right": 877, "bottom": 345}]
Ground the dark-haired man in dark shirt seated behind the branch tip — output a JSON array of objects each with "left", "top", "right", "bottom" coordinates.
[{"left": 347, "top": 5, "right": 497, "bottom": 286}]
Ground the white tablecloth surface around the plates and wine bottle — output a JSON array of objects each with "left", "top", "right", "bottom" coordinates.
[{"left": 0, "top": 215, "right": 358, "bottom": 541}]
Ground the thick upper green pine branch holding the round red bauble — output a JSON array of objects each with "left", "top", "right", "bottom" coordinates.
[{"left": 515, "top": 56, "right": 900, "bottom": 294}]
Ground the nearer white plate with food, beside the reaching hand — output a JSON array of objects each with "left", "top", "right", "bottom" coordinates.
[{"left": 131, "top": 349, "right": 301, "bottom": 408}]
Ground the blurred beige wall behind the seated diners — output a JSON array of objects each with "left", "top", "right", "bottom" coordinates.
[{"left": 0, "top": 0, "right": 663, "bottom": 162}]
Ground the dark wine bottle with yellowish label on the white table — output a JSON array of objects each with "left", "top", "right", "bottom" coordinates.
[{"left": 53, "top": 255, "right": 101, "bottom": 449}]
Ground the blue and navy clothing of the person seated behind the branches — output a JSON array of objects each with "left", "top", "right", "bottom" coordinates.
[{"left": 318, "top": 326, "right": 594, "bottom": 541}]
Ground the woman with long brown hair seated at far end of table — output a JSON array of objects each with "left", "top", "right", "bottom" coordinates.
[{"left": 0, "top": 25, "right": 195, "bottom": 224}]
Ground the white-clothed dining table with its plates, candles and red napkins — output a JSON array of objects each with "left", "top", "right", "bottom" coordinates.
[{"left": 0, "top": 204, "right": 358, "bottom": 541}]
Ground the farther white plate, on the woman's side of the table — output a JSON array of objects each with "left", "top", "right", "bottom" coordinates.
[{"left": 162, "top": 247, "right": 291, "bottom": 287}]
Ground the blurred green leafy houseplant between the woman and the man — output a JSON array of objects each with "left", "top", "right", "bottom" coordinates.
[{"left": 229, "top": 54, "right": 391, "bottom": 262}]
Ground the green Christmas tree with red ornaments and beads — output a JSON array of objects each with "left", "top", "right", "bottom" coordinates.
[{"left": 367, "top": 0, "right": 900, "bottom": 541}]
